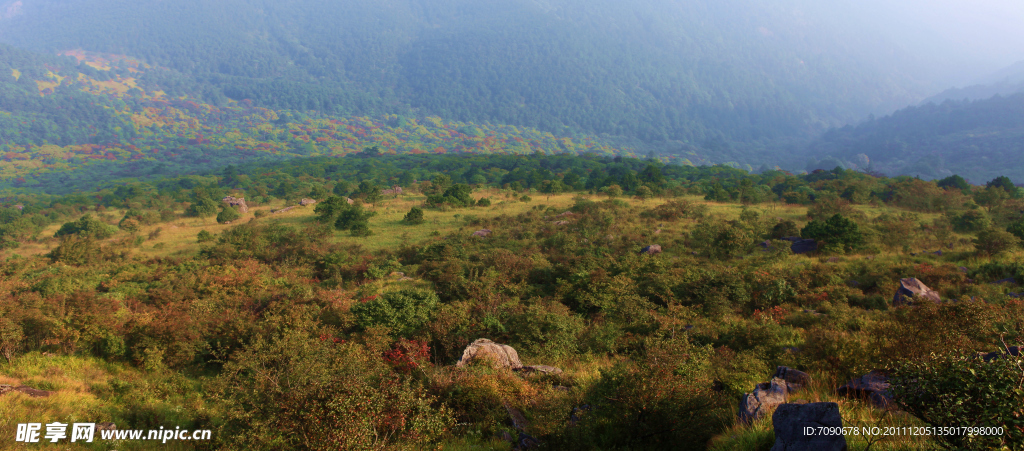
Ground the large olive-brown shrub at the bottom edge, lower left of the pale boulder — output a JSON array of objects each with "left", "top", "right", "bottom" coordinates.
[{"left": 214, "top": 329, "right": 454, "bottom": 451}]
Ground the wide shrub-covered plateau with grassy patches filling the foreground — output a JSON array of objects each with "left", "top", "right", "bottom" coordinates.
[{"left": 0, "top": 153, "right": 1024, "bottom": 451}]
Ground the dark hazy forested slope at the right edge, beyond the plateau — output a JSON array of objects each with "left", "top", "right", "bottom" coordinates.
[{"left": 808, "top": 93, "right": 1024, "bottom": 183}]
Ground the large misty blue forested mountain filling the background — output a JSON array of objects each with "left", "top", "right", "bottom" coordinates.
[{"left": 0, "top": 0, "right": 927, "bottom": 161}]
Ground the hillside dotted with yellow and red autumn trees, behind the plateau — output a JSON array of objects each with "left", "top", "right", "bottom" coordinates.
[{"left": 0, "top": 46, "right": 684, "bottom": 193}]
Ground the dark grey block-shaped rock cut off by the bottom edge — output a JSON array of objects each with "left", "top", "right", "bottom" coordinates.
[{"left": 771, "top": 403, "right": 847, "bottom": 451}]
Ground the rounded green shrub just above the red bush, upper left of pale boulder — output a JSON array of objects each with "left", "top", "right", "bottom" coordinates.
[{"left": 352, "top": 289, "right": 440, "bottom": 337}]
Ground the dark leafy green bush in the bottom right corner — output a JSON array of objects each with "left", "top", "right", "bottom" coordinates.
[{"left": 890, "top": 354, "right": 1024, "bottom": 450}]
